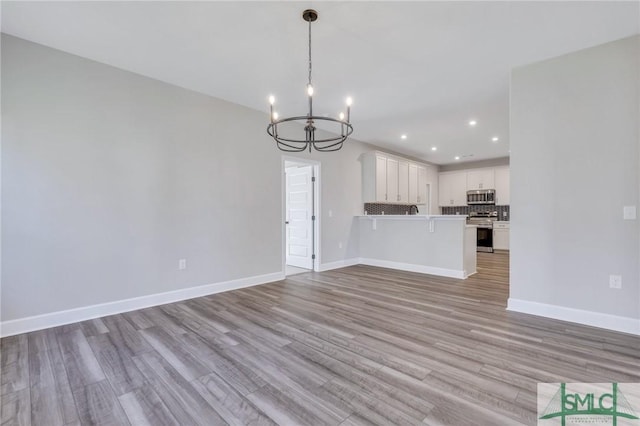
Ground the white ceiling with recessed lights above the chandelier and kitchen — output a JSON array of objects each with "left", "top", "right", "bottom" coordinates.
[{"left": 1, "top": 1, "right": 640, "bottom": 164}]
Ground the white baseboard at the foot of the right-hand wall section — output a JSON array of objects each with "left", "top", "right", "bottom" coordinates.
[{"left": 507, "top": 298, "right": 640, "bottom": 336}]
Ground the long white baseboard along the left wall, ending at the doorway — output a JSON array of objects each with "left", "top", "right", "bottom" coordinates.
[{"left": 0, "top": 272, "right": 284, "bottom": 337}]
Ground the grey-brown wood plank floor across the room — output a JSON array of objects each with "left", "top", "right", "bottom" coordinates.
[{"left": 1, "top": 253, "right": 640, "bottom": 426}]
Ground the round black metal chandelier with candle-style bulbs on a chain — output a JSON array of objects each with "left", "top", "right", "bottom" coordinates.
[{"left": 267, "top": 9, "right": 353, "bottom": 152}]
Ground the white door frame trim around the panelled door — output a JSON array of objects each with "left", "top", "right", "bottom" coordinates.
[{"left": 280, "top": 155, "right": 322, "bottom": 275}]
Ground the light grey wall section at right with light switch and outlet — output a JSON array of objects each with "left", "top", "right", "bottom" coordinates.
[{"left": 510, "top": 37, "right": 640, "bottom": 331}]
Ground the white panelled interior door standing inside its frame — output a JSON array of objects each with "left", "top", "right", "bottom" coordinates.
[{"left": 285, "top": 166, "right": 313, "bottom": 269}]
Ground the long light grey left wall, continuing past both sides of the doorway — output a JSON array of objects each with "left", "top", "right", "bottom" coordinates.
[{"left": 0, "top": 35, "right": 373, "bottom": 322}]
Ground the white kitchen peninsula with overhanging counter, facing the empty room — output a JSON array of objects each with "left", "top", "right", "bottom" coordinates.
[{"left": 357, "top": 215, "right": 476, "bottom": 278}]
